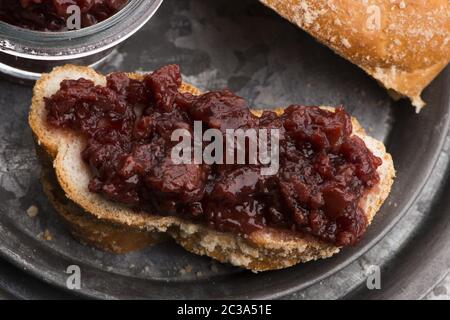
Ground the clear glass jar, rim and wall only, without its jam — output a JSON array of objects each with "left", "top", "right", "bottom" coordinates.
[{"left": 0, "top": 0, "right": 162, "bottom": 81}]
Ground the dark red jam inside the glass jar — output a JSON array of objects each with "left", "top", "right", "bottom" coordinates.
[{"left": 0, "top": 0, "right": 128, "bottom": 31}]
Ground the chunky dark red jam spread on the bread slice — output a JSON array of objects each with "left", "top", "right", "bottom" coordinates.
[{"left": 45, "top": 65, "right": 382, "bottom": 246}]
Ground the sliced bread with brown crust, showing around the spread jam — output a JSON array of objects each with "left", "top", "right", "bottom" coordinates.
[{"left": 29, "top": 65, "right": 395, "bottom": 272}]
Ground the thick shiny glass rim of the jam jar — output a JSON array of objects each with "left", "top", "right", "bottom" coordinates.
[{"left": 0, "top": 0, "right": 163, "bottom": 60}]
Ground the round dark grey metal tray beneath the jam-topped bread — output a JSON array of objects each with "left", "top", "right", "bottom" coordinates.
[{"left": 0, "top": 0, "right": 450, "bottom": 299}]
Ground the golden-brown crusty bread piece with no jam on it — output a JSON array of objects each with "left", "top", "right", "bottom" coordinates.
[{"left": 260, "top": 0, "right": 450, "bottom": 111}]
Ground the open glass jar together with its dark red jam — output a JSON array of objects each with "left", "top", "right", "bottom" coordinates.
[{"left": 0, "top": 0, "right": 162, "bottom": 81}]
